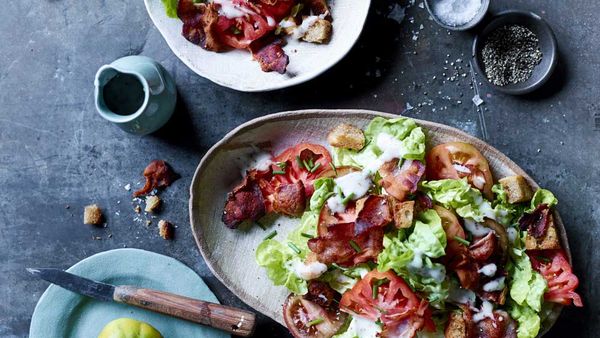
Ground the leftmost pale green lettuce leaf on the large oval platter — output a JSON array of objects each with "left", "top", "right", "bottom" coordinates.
[{"left": 256, "top": 239, "right": 308, "bottom": 295}]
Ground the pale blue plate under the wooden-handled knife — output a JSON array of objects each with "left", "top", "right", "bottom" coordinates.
[{"left": 29, "top": 249, "right": 230, "bottom": 338}]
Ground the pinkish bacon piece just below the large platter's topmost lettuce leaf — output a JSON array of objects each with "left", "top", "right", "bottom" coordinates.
[{"left": 379, "top": 159, "right": 425, "bottom": 201}]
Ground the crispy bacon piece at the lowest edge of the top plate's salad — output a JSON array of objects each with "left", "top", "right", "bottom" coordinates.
[{"left": 250, "top": 39, "right": 290, "bottom": 74}]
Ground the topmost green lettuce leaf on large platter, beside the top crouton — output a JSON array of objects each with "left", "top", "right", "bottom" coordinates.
[{"left": 333, "top": 117, "right": 425, "bottom": 168}]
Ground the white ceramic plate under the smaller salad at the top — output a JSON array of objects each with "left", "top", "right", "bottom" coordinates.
[{"left": 144, "top": 0, "right": 371, "bottom": 92}]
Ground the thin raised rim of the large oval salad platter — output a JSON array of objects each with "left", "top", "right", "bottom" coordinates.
[{"left": 188, "top": 109, "right": 572, "bottom": 337}]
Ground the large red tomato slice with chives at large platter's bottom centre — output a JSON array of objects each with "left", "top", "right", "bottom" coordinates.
[{"left": 340, "top": 269, "right": 435, "bottom": 337}]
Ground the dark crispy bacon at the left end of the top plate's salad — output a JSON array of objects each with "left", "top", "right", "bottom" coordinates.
[{"left": 177, "top": 0, "right": 225, "bottom": 52}]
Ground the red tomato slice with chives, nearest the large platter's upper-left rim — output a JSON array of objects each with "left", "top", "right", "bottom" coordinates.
[{"left": 271, "top": 143, "right": 331, "bottom": 198}]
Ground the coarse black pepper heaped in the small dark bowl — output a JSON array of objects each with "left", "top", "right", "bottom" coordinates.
[{"left": 481, "top": 25, "right": 542, "bottom": 86}]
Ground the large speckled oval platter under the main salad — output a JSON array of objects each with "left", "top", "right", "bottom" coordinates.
[{"left": 189, "top": 110, "right": 570, "bottom": 336}]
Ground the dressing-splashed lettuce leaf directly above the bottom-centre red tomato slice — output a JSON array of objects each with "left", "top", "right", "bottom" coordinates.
[{"left": 377, "top": 210, "right": 449, "bottom": 308}]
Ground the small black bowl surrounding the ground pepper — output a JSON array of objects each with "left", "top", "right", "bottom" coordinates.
[{"left": 472, "top": 10, "right": 558, "bottom": 95}]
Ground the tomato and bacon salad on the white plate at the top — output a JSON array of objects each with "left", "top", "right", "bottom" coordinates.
[{"left": 163, "top": 0, "right": 333, "bottom": 74}]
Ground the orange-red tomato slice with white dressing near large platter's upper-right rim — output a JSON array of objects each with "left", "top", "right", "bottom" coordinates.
[{"left": 426, "top": 142, "right": 494, "bottom": 199}]
